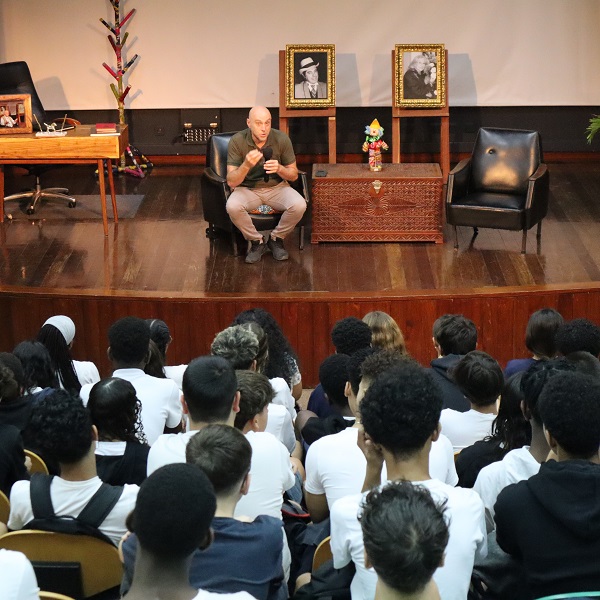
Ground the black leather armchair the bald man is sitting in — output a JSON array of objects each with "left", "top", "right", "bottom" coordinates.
[{"left": 201, "top": 132, "right": 309, "bottom": 256}]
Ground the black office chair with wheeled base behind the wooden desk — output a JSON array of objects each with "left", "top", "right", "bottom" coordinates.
[{"left": 0, "top": 61, "right": 79, "bottom": 215}]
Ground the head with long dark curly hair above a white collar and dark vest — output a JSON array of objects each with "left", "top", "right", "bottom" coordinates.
[{"left": 87, "top": 377, "right": 146, "bottom": 443}]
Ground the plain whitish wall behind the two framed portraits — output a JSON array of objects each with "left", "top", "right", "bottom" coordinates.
[{"left": 0, "top": 0, "right": 600, "bottom": 110}]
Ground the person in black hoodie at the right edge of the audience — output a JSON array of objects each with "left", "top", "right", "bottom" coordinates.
[{"left": 495, "top": 372, "right": 600, "bottom": 598}]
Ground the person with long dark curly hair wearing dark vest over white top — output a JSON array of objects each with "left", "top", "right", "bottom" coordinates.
[{"left": 88, "top": 377, "right": 150, "bottom": 485}]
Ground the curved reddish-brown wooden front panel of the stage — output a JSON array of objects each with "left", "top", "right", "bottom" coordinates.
[{"left": 0, "top": 286, "right": 600, "bottom": 387}]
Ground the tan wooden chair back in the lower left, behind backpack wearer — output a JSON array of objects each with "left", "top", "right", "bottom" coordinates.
[{"left": 0, "top": 529, "right": 123, "bottom": 598}]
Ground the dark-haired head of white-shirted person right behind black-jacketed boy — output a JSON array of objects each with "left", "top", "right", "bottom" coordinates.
[{"left": 451, "top": 350, "right": 504, "bottom": 406}]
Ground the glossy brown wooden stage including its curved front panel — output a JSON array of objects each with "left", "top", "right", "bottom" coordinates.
[{"left": 0, "top": 163, "right": 600, "bottom": 382}]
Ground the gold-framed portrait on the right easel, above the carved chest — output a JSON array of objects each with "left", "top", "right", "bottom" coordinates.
[{"left": 394, "top": 44, "right": 446, "bottom": 108}]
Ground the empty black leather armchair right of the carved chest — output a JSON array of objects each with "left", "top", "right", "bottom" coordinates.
[{"left": 446, "top": 128, "right": 550, "bottom": 254}]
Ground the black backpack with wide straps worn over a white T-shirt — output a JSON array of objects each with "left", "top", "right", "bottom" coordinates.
[{"left": 23, "top": 473, "right": 123, "bottom": 546}]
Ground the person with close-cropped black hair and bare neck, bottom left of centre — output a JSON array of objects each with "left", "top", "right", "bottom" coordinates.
[{"left": 122, "top": 464, "right": 252, "bottom": 600}]
